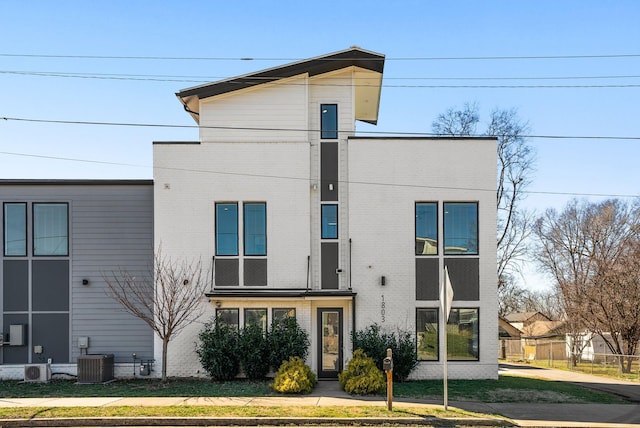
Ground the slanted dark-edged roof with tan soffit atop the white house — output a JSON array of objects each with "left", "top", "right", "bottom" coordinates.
[{"left": 176, "top": 47, "right": 384, "bottom": 124}]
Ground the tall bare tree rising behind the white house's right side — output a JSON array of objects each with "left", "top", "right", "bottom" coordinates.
[{"left": 431, "top": 103, "right": 535, "bottom": 289}]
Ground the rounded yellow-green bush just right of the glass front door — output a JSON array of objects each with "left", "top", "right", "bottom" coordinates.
[{"left": 338, "top": 349, "right": 386, "bottom": 395}]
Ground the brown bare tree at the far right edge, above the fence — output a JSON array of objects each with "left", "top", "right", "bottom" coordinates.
[{"left": 535, "top": 199, "right": 640, "bottom": 372}]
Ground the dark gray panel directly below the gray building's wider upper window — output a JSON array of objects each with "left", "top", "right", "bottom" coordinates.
[{"left": 31, "top": 260, "right": 69, "bottom": 311}]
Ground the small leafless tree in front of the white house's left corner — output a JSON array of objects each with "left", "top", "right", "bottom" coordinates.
[{"left": 103, "top": 250, "right": 210, "bottom": 382}]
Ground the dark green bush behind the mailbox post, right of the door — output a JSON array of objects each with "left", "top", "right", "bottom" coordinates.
[{"left": 351, "top": 324, "right": 418, "bottom": 382}]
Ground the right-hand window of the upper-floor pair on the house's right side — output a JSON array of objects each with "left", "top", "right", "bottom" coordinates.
[{"left": 444, "top": 202, "right": 478, "bottom": 255}]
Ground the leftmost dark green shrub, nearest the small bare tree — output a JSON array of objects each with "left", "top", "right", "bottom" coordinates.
[{"left": 196, "top": 319, "right": 240, "bottom": 381}]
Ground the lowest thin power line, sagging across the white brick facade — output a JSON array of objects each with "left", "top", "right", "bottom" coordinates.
[{"left": 0, "top": 151, "right": 640, "bottom": 198}]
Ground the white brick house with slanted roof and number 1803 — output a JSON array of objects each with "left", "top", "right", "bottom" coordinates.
[{"left": 154, "top": 48, "right": 498, "bottom": 378}]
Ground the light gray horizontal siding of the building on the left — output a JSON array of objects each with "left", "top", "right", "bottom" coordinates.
[{"left": 0, "top": 180, "right": 153, "bottom": 362}]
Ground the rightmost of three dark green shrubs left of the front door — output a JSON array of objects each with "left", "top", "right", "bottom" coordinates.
[{"left": 269, "top": 317, "right": 309, "bottom": 371}]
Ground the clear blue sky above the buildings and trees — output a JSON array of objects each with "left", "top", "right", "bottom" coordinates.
[{"left": 0, "top": 0, "right": 640, "bottom": 289}]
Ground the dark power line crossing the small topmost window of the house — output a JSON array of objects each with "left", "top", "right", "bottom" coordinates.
[{"left": 0, "top": 117, "right": 640, "bottom": 141}]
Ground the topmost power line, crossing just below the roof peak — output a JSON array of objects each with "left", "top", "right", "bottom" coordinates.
[{"left": 0, "top": 52, "right": 640, "bottom": 61}]
